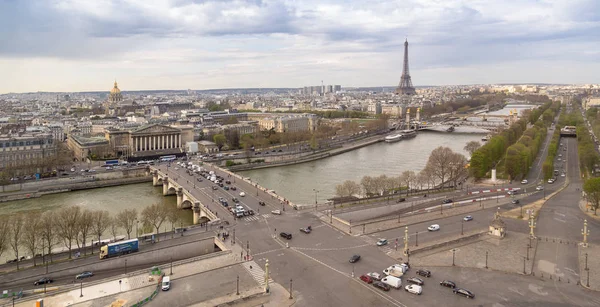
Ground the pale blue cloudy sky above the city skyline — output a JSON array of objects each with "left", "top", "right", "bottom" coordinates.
[{"left": 0, "top": 0, "right": 600, "bottom": 93}]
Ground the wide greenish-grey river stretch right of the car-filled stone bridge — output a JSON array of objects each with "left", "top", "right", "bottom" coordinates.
[{"left": 241, "top": 131, "right": 482, "bottom": 204}]
